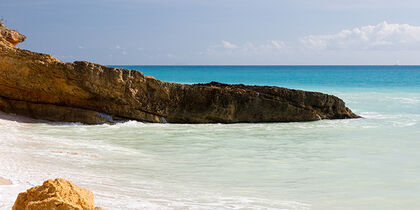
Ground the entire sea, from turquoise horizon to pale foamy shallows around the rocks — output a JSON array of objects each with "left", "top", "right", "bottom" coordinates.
[{"left": 0, "top": 66, "right": 420, "bottom": 209}]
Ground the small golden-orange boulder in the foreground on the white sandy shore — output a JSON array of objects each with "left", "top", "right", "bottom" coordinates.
[{"left": 12, "top": 179, "right": 95, "bottom": 210}]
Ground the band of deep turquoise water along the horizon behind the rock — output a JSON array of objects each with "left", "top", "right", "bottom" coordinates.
[{"left": 113, "top": 66, "right": 420, "bottom": 92}]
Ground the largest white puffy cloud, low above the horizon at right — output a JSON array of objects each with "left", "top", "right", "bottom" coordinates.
[{"left": 301, "top": 22, "right": 420, "bottom": 50}]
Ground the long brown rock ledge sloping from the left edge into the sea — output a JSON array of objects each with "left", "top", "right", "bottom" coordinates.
[{"left": 0, "top": 23, "right": 358, "bottom": 124}]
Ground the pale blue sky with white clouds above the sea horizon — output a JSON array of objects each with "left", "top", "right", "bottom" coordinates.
[{"left": 0, "top": 0, "right": 420, "bottom": 65}]
